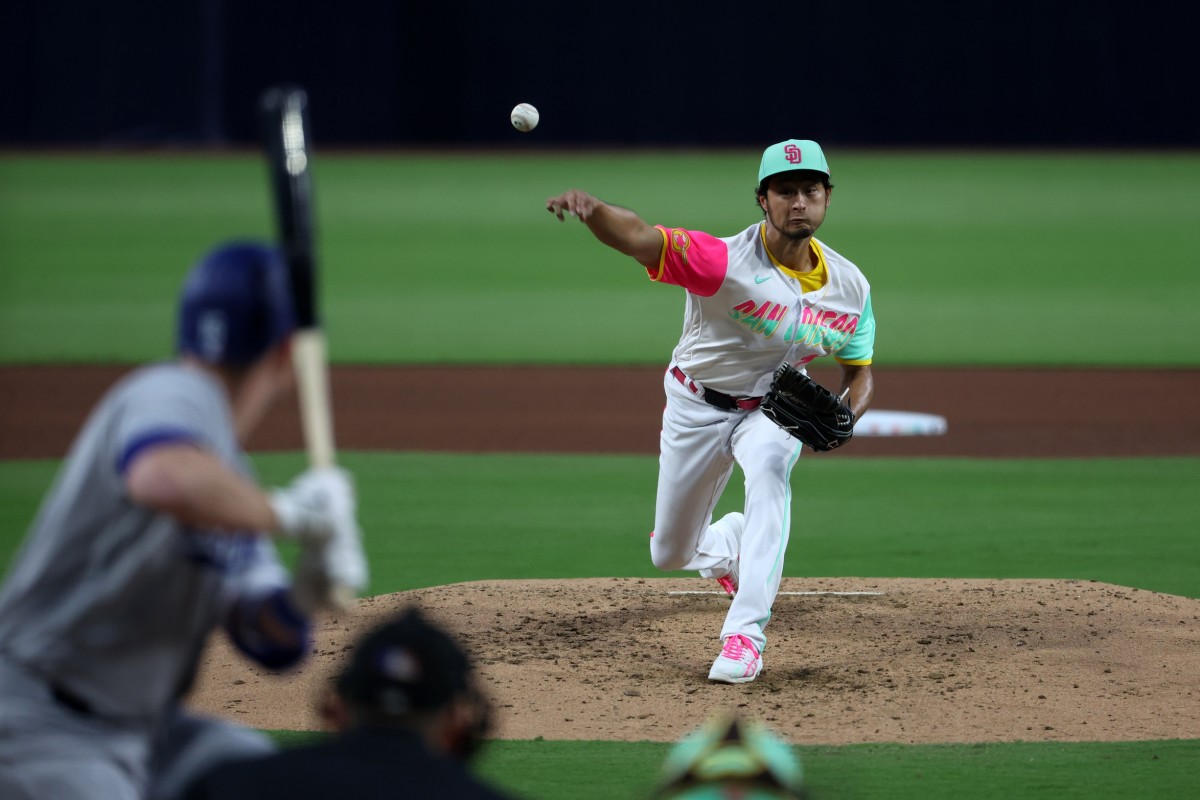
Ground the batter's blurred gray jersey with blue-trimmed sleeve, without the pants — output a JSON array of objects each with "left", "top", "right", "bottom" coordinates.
[{"left": 0, "top": 365, "right": 287, "bottom": 720}]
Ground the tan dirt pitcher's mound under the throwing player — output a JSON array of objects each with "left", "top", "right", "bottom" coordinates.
[{"left": 191, "top": 578, "right": 1200, "bottom": 744}]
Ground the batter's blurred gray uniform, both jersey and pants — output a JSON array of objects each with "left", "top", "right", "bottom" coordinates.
[{"left": 0, "top": 363, "right": 307, "bottom": 800}]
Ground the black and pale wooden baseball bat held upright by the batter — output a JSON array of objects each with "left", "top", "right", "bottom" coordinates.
[{"left": 259, "top": 85, "right": 354, "bottom": 609}]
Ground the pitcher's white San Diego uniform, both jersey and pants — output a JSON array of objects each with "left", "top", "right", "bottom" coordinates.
[{"left": 648, "top": 223, "right": 875, "bottom": 662}]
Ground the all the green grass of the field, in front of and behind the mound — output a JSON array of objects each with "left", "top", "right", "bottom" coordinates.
[{"left": 0, "top": 146, "right": 1200, "bottom": 800}]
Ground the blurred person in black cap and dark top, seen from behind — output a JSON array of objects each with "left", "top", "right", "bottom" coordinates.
[{"left": 187, "top": 609, "right": 513, "bottom": 800}]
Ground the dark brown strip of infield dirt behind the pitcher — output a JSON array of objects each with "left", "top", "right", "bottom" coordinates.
[{"left": 7, "top": 366, "right": 1200, "bottom": 458}]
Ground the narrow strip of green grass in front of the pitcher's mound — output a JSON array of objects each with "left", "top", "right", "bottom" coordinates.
[{"left": 270, "top": 732, "right": 1200, "bottom": 800}]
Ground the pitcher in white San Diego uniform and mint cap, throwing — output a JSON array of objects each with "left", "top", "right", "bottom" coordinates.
[{"left": 546, "top": 139, "right": 875, "bottom": 684}]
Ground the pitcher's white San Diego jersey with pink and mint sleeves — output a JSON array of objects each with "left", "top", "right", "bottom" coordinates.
[{"left": 647, "top": 222, "right": 875, "bottom": 397}]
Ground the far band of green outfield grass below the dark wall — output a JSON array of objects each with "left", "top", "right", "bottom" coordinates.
[{"left": 0, "top": 148, "right": 1200, "bottom": 366}]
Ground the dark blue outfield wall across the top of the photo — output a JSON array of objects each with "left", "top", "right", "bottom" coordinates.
[{"left": 0, "top": 0, "right": 1200, "bottom": 146}]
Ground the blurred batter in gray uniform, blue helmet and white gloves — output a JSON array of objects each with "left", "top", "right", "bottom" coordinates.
[{"left": 0, "top": 243, "right": 366, "bottom": 800}]
